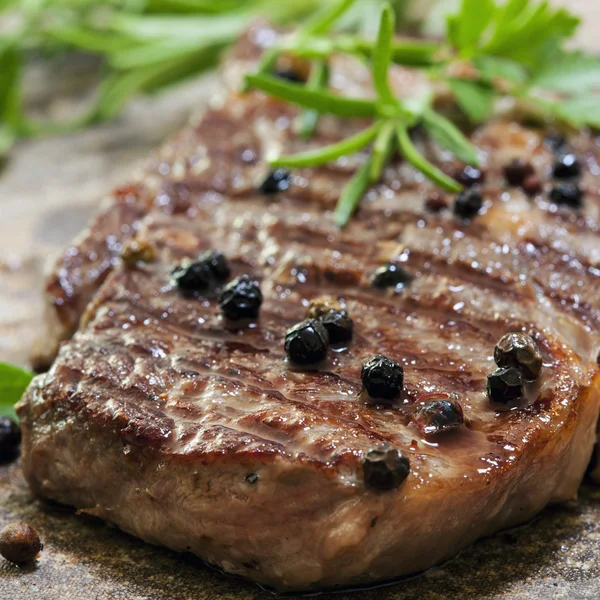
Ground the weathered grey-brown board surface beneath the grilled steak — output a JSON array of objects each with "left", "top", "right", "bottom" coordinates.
[{"left": 0, "top": 0, "right": 600, "bottom": 600}]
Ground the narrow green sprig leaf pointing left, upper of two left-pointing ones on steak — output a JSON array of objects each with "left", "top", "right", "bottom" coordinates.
[{"left": 246, "top": 75, "right": 377, "bottom": 117}]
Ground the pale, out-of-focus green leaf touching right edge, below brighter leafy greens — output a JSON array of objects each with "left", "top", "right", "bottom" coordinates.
[{"left": 530, "top": 52, "right": 600, "bottom": 93}]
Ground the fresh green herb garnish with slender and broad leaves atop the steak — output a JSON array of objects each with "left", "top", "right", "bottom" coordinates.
[{"left": 247, "top": 0, "right": 600, "bottom": 226}]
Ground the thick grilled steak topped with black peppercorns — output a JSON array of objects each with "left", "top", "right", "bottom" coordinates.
[{"left": 18, "top": 24, "right": 600, "bottom": 590}]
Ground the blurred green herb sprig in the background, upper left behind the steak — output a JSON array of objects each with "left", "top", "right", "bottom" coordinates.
[{"left": 0, "top": 0, "right": 342, "bottom": 159}]
